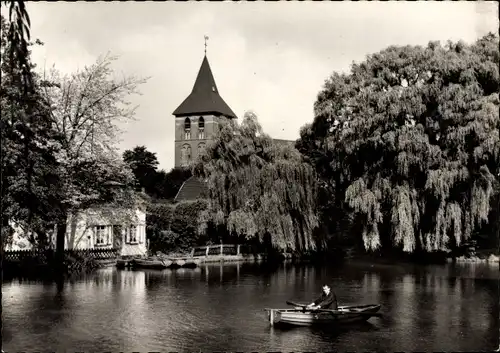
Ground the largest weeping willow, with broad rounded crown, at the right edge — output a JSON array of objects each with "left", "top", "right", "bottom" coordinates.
[{"left": 297, "top": 34, "right": 500, "bottom": 252}]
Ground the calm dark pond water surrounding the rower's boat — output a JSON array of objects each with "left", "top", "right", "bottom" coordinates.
[{"left": 2, "top": 263, "right": 499, "bottom": 352}]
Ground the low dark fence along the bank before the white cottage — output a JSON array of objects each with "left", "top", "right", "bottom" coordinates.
[{"left": 3, "top": 249, "right": 119, "bottom": 262}]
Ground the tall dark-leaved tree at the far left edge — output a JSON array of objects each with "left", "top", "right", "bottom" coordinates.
[{"left": 0, "top": 17, "right": 58, "bottom": 245}]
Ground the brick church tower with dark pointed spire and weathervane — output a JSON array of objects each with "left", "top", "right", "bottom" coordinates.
[{"left": 173, "top": 47, "right": 236, "bottom": 167}]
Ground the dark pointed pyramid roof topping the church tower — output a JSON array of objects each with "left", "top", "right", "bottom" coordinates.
[{"left": 173, "top": 56, "right": 236, "bottom": 118}]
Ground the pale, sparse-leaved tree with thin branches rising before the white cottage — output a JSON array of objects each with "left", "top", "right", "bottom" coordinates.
[{"left": 36, "top": 55, "right": 146, "bottom": 256}]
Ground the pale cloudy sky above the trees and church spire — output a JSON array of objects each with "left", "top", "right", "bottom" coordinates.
[{"left": 27, "top": 1, "right": 499, "bottom": 171}]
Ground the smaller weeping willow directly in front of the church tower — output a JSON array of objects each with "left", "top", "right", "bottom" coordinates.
[{"left": 193, "top": 113, "right": 318, "bottom": 252}]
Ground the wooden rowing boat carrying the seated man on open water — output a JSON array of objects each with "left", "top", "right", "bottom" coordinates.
[{"left": 265, "top": 304, "right": 380, "bottom": 326}]
